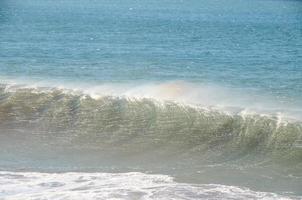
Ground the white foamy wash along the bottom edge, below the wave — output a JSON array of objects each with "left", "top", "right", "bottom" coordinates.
[{"left": 0, "top": 171, "right": 300, "bottom": 200}]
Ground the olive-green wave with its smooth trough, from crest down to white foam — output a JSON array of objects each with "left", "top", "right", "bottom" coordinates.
[{"left": 0, "top": 85, "right": 302, "bottom": 194}]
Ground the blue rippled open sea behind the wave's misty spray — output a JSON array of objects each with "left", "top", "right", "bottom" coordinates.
[{"left": 0, "top": 0, "right": 302, "bottom": 101}]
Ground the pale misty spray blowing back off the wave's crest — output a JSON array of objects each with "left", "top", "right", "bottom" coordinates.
[{"left": 0, "top": 78, "right": 302, "bottom": 121}]
